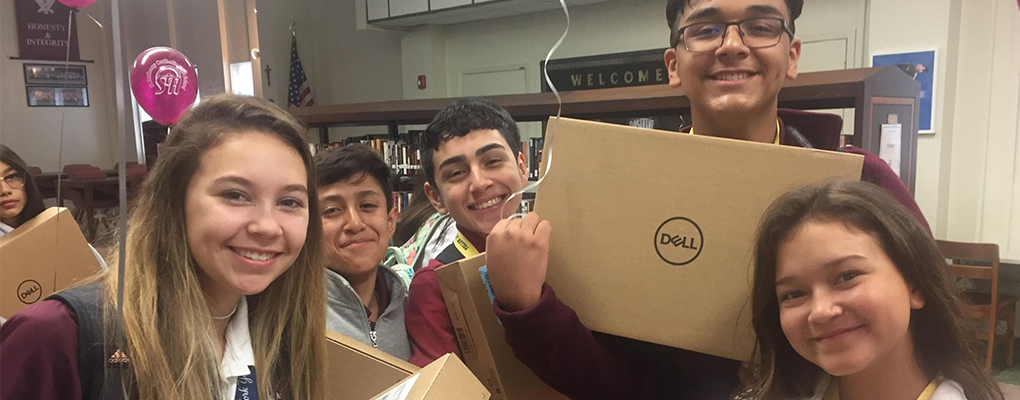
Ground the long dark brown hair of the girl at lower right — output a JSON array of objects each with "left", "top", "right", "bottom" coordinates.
[{"left": 741, "top": 182, "right": 1003, "bottom": 400}]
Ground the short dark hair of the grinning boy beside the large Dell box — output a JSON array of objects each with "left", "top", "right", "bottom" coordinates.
[{"left": 421, "top": 98, "right": 520, "bottom": 190}]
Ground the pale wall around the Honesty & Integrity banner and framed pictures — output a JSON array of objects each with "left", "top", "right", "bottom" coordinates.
[{"left": 0, "top": 0, "right": 116, "bottom": 170}]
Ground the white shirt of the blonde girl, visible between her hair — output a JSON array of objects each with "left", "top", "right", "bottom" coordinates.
[{"left": 219, "top": 296, "right": 258, "bottom": 400}]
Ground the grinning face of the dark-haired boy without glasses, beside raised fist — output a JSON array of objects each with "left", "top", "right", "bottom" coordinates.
[{"left": 425, "top": 130, "right": 527, "bottom": 236}]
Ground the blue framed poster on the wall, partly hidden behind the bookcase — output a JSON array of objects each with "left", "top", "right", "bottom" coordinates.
[{"left": 871, "top": 50, "right": 938, "bottom": 135}]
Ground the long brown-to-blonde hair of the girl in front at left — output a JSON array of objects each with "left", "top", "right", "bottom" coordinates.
[{"left": 100, "top": 95, "right": 325, "bottom": 400}]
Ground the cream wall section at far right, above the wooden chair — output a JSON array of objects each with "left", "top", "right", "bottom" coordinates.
[{"left": 942, "top": 0, "right": 1020, "bottom": 259}]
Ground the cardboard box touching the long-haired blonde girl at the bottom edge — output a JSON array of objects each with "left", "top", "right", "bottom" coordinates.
[{"left": 325, "top": 331, "right": 420, "bottom": 400}]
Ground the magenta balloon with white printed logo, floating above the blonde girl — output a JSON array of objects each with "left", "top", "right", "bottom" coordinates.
[{"left": 131, "top": 47, "right": 198, "bottom": 124}]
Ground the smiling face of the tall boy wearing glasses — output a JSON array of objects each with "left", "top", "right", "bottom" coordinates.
[{"left": 665, "top": 0, "right": 801, "bottom": 139}]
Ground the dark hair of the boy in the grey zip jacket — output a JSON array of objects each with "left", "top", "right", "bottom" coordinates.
[{"left": 315, "top": 144, "right": 393, "bottom": 212}]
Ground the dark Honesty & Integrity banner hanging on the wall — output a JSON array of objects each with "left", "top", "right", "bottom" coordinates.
[{"left": 14, "top": 0, "right": 82, "bottom": 61}]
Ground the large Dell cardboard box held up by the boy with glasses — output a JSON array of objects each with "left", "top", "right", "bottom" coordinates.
[{"left": 536, "top": 118, "right": 864, "bottom": 360}]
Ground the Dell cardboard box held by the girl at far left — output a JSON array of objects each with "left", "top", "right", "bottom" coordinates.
[{"left": 0, "top": 207, "right": 101, "bottom": 318}]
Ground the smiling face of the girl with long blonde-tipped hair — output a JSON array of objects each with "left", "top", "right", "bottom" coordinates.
[{"left": 185, "top": 132, "right": 308, "bottom": 302}]
